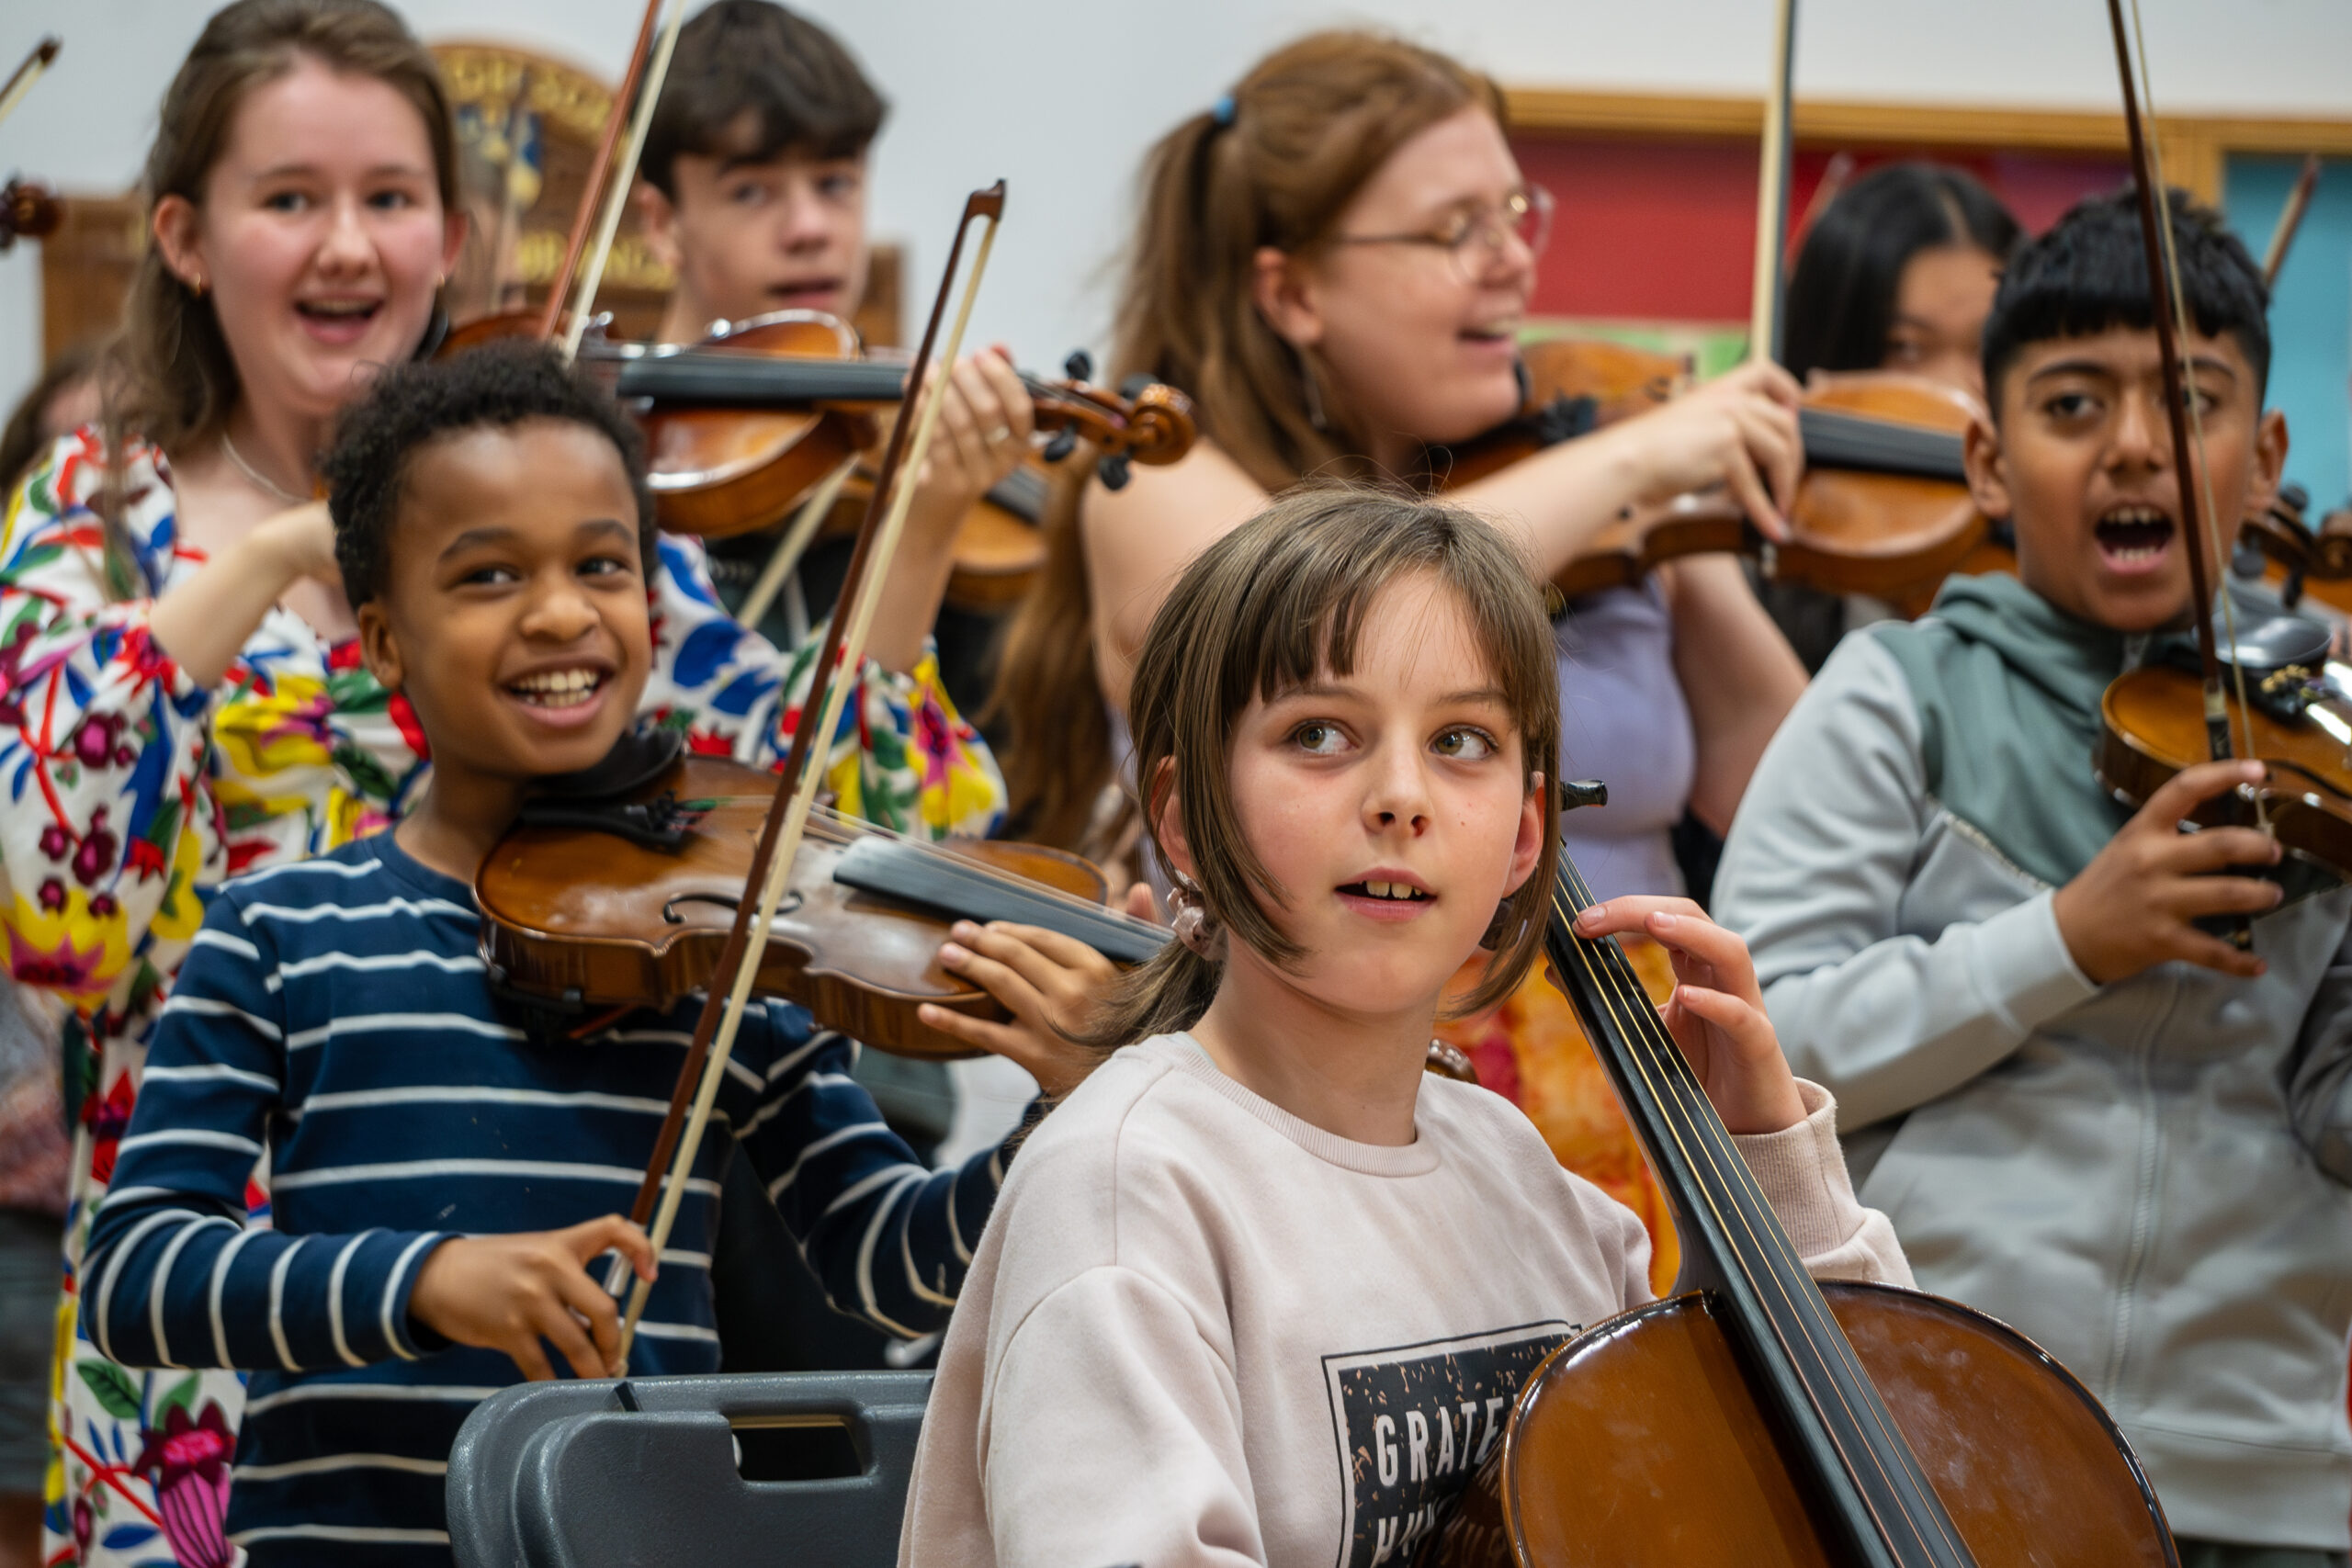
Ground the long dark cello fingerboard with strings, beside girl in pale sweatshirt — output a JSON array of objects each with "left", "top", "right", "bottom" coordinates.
[{"left": 1555, "top": 858, "right": 1966, "bottom": 1561}]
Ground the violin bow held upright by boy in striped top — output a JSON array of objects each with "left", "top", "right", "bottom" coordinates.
[{"left": 621, "top": 181, "right": 1004, "bottom": 1361}]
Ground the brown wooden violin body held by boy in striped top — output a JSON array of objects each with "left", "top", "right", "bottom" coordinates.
[{"left": 475, "top": 757, "right": 1105, "bottom": 1058}]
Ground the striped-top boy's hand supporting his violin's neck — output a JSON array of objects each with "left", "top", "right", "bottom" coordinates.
[{"left": 917, "top": 882, "right": 1159, "bottom": 1100}]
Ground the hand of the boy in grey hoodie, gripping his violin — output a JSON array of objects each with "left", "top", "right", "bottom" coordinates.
[{"left": 2051, "top": 761, "right": 2286, "bottom": 985}]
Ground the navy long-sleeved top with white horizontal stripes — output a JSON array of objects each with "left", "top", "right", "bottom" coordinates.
[{"left": 83, "top": 835, "right": 1004, "bottom": 1568}]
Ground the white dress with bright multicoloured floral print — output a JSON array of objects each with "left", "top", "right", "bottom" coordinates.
[{"left": 16, "top": 430, "right": 1004, "bottom": 1568}]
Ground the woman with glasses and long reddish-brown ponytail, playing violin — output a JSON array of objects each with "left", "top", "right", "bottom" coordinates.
[{"left": 1000, "top": 33, "right": 1804, "bottom": 894}]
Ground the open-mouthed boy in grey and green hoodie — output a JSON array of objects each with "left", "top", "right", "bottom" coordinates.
[{"left": 1714, "top": 193, "right": 2352, "bottom": 1568}]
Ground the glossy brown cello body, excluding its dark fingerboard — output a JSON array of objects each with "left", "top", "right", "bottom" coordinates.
[{"left": 1430, "top": 1283, "right": 2180, "bottom": 1568}]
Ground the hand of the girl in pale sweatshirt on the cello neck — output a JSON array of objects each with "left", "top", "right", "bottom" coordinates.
[{"left": 1576, "top": 896, "right": 1804, "bottom": 1134}]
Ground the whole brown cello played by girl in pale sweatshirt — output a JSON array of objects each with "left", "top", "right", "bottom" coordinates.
[{"left": 1432, "top": 799, "right": 2178, "bottom": 1568}]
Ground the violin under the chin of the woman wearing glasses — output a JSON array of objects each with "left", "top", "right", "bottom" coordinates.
[{"left": 1432, "top": 339, "right": 1987, "bottom": 600}]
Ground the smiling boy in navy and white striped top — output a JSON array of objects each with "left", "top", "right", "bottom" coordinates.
[{"left": 83, "top": 350, "right": 1108, "bottom": 1563}]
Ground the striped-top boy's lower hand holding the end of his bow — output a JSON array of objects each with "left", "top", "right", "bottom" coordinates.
[{"left": 409, "top": 1213, "right": 654, "bottom": 1382}]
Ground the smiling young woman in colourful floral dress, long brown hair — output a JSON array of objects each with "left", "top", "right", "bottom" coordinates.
[{"left": 0, "top": 0, "right": 1002, "bottom": 1563}]
